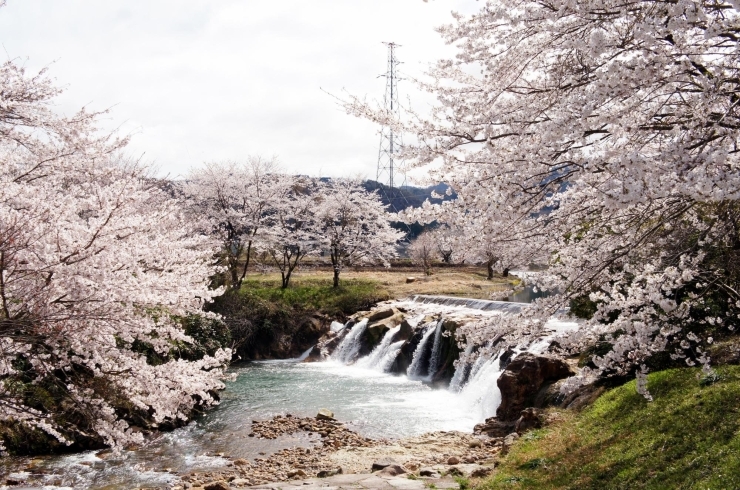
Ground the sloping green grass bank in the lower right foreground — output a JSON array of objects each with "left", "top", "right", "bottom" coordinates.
[{"left": 477, "top": 366, "right": 740, "bottom": 490}]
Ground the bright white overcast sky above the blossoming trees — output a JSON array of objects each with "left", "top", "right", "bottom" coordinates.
[{"left": 0, "top": 0, "right": 481, "bottom": 178}]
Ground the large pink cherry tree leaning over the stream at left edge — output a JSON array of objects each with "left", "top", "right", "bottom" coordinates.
[{"left": 0, "top": 61, "right": 230, "bottom": 452}]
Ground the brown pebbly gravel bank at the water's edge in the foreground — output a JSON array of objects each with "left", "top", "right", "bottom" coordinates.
[{"left": 174, "top": 411, "right": 503, "bottom": 490}]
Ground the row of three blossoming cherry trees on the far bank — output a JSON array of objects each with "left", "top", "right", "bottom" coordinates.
[{"left": 182, "top": 161, "right": 403, "bottom": 290}]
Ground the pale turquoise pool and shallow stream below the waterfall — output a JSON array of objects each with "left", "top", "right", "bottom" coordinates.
[{"left": 2, "top": 282, "right": 572, "bottom": 490}]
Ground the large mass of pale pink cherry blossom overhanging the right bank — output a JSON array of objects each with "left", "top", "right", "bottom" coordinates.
[{"left": 347, "top": 0, "right": 740, "bottom": 386}]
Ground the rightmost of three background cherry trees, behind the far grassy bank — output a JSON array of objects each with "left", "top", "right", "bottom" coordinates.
[{"left": 318, "top": 179, "right": 403, "bottom": 288}]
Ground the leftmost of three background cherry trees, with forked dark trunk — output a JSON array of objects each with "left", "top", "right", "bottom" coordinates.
[{"left": 183, "top": 157, "right": 293, "bottom": 290}]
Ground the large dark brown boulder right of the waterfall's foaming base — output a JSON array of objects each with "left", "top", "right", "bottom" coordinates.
[{"left": 496, "top": 353, "right": 575, "bottom": 421}]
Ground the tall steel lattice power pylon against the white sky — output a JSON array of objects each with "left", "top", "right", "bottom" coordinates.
[{"left": 375, "top": 43, "right": 406, "bottom": 189}]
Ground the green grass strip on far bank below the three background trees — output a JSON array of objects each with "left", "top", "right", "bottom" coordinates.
[{"left": 241, "top": 277, "right": 390, "bottom": 317}]
